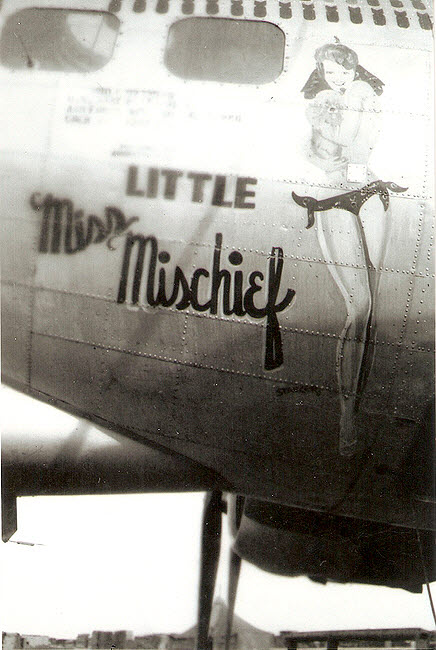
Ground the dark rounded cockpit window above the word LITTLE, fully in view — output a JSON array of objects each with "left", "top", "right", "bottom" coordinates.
[{"left": 165, "top": 18, "right": 285, "bottom": 84}]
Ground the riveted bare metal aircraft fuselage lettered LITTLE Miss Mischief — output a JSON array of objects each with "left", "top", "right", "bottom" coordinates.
[{"left": 0, "top": 0, "right": 434, "bottom": 529}]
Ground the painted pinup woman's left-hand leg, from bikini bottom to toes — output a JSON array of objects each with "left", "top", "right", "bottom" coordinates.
[{"left": 317, "top": 209, "right": 373, "bottom": 456}]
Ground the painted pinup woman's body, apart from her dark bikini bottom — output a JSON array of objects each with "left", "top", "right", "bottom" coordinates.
[{"left": 302, "top": 42, "right": 390, "bottom": 456}]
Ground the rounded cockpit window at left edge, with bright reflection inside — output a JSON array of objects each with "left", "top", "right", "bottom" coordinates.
[{"left": 0, "top": 8, "right": 120, "bottom": 72}]
